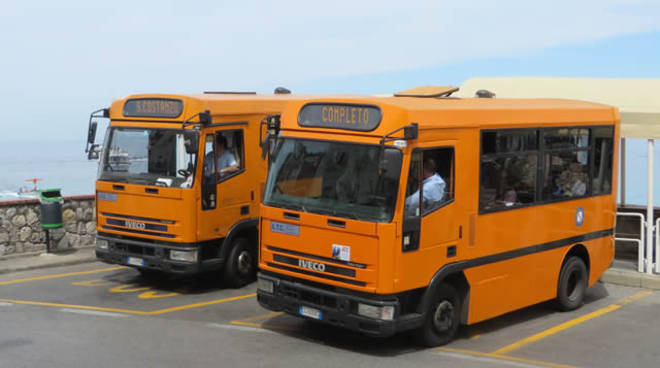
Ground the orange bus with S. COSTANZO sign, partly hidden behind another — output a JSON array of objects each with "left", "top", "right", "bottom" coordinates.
[{"left": 87, "top": 90, "right": 302, "bottom": 287}]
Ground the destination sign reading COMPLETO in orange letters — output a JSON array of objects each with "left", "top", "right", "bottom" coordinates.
[{"left": 298, "top": 103, "right": 383, "bottom": 132}]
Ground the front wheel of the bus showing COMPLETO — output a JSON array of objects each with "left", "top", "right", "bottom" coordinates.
[{"left": 417, "top": 283, "right": 461, "bottom": 347}]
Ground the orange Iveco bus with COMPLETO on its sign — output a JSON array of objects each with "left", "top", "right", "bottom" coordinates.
[{"left": 257, "top": 88, "right": 619, "bottom": 346}]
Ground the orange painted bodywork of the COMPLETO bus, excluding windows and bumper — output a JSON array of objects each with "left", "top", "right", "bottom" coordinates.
[{"left": 260, "top": 97, "right": 619, "bottom": 323}]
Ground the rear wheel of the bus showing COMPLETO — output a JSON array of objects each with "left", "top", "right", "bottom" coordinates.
[{"left": 557, "top": 257, "right": 588, "bottom": 311}]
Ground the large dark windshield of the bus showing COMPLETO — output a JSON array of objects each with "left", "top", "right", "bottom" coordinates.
[{"left": 264, "top": 138, "right": 402, "bottom": 222}]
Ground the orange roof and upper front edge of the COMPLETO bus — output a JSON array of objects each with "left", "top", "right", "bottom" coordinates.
[{"left": 282, "top": 96, "right": 618, "bottom": 136}]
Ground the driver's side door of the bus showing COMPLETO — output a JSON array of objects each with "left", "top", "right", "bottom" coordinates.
[{"left": 401, "top": 142, "right": 463, "bottom": 274}]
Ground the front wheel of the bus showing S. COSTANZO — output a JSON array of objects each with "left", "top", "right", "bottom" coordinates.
[{"left": 223, "top": 238, "right": 257, "bottom": 288}]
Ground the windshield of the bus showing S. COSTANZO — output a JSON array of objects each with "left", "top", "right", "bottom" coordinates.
[{"left": 98, "top": 127, "right": 197, "bottom": 188}]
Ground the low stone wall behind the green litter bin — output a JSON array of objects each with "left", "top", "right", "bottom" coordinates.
[{"left": 0, "top": 195, "right": 96, "bottom": 256}]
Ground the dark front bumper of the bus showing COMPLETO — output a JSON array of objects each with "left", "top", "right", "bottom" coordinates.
[{"left": 257, "top": 272, "right": 423, "bottom": 337}]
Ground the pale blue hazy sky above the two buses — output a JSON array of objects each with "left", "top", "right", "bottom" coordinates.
[{"left": 0, "top": 0, "right": 660, "bottom": 143}]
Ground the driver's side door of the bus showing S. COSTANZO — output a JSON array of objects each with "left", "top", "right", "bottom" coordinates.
[{"left": 198, "top": 125, "right": 251, "bottom": 239}]
